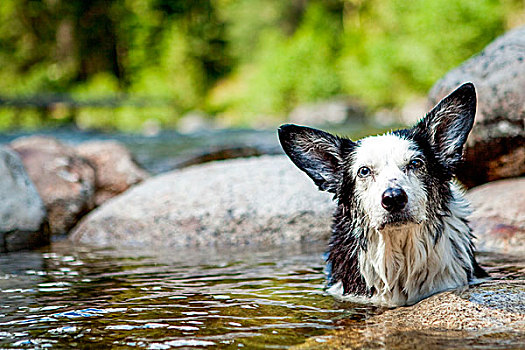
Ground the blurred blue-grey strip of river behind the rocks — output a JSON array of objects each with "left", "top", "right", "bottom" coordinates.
[{"left": 0, "top": 122, "right": 382, "bottom": 174}]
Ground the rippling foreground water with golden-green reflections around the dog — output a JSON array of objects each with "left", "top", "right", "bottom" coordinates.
[{"left": 0, "top": 242, "right": 524, "bottom": 349}]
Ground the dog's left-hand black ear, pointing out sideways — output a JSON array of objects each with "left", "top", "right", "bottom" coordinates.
[{"left": 279, "top": 124, "right": 354, "bottom": 193}]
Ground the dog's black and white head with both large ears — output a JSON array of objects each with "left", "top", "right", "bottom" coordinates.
[{"left": 279, "top": 83, "right": 476, "bottom": 230}]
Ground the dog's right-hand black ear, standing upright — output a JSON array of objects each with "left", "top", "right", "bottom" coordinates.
[{"left": 414, "top": 83, "right": 476, "bottom": 171}]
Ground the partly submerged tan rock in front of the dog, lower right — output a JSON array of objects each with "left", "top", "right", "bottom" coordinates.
[{"left": 297, "top": 280, "right": 525, "bottom": 349}]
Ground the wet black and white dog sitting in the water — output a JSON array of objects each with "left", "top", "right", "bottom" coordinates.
[{"left": 279, "top": 83, "right": 487, "bottom": 306}]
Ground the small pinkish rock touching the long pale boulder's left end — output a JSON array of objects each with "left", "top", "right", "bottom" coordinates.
[{"left": 75, "top": 141, "right": 149, "bottom": 206}]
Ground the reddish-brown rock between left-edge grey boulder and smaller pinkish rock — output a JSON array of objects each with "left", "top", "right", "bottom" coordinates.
[{"left": 10, "top": 136, "right": 95, "bottom": 235}]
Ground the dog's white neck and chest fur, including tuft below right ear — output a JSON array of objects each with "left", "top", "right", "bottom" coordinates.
[{"left": 358, "top": 185, "right": 473, "bottom": 305}]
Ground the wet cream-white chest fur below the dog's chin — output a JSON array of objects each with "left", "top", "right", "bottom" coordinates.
[{"left": 358, "top": 227, "right": 468, "bottom": 305}]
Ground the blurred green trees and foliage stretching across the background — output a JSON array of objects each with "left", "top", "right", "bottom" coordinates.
[{"left": 0, "top": 0, "right": 525, "bottom": 131}]
